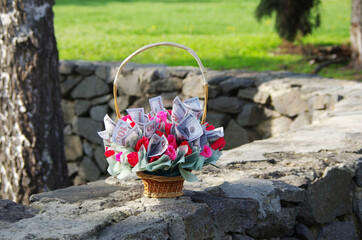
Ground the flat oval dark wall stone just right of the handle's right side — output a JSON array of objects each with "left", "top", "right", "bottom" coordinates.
[{"left": 208, "top": 96, "right": 246, "bottom": 113}]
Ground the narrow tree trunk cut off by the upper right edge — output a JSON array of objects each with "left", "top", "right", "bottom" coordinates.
[{"left": 351, "top": 0, "right": 362, "bottom": 69}]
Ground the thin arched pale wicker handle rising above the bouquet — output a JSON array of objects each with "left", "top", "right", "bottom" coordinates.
[{"left": 113, "top": 42, "right": 208, "bottom": 124}]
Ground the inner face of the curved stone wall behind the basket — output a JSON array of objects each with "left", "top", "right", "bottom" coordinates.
[{"left": 59, "top": 61, "right": 340, "bottom": 185}]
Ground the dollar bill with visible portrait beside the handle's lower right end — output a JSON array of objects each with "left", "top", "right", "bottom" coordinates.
[{"left": 176, "top": 114, "right": 203, "bottom": 142}]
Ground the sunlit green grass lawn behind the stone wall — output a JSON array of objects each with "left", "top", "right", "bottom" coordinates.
[{"left": 54, "top": 0, "right": 351, "bottom": 79}]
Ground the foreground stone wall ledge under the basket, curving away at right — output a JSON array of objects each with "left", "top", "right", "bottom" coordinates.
[{"left": 0, "top": 74, "right": 362, "bottom": 240}]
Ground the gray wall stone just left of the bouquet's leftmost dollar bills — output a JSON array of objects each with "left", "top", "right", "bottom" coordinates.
[{"left": 73, "top": 117, "right": 104, "bottom": 144}]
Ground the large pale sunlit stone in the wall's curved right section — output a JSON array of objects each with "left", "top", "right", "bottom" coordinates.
[{"left": 272, "top": 89, "right": 308, "bottom": 117}]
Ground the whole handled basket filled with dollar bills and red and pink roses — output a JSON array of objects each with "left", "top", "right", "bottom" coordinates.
[{"left": 98, "top": 43, "right": 225, "bottom": 197}]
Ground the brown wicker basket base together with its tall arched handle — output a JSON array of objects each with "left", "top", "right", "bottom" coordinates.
[{"left": 113, "top": 42, "right": 208, "bottom": 198}]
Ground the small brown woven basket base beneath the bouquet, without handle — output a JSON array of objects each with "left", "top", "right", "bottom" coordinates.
[{"left": 137, "top": 172, "right": 185, "bottom": 198}]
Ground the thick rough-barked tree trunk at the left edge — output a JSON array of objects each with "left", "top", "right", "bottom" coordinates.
[{"left": 0, "top": 0, "right": 68, "bottom": 204}]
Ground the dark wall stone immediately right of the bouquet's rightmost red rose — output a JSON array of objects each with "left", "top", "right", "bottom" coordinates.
[{"left": 224, "top": 120, "right": 249, "bottom": 149}]
